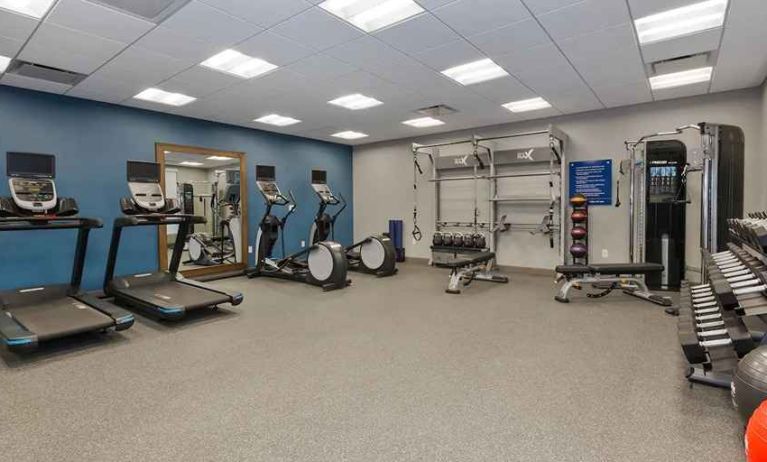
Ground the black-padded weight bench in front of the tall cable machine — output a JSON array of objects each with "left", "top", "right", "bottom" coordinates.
[{"left": 554, "top": 263, "right": 672, "bottom": 306}]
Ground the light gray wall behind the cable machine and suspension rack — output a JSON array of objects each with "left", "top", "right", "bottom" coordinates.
[{"left": 353, "top": 88, "right": 767, "bottom": 268}]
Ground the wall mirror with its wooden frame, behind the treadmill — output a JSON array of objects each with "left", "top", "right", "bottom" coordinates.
[{"left": 155, "top": 143, "right": 248, "bottom": 277}]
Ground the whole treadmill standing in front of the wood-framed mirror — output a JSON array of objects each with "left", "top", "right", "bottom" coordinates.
[{"left": 104, "top": 161, "right": 242, "bottom": 320}]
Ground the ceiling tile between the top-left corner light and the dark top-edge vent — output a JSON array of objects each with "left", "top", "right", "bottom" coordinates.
[{"left": 45, "top": 0, "right": 155, "bottom": 43}]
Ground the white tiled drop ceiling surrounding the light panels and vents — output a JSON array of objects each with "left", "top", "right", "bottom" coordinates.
[{"left": 0, "top": 0, "right": 767, "bottom": 144}]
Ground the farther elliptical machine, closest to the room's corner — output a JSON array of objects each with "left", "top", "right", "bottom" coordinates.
[{"left": 309, "top": 170, "right": 397, "bottom": 277}]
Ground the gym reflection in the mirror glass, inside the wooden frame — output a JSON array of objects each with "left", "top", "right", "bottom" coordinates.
[{"left": 164, "top": 151, "right": 243, "bottom": 271}]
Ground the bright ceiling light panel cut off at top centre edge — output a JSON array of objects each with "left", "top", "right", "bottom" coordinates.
[{"left": 320, "top": 0, "right": 424, "bottom": 32}]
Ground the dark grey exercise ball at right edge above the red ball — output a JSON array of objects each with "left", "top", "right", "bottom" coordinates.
[{"left": 731, "top": 346, "right": 767, "bottom": 423}]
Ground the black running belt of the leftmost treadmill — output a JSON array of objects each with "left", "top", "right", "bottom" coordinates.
[{"left": 6, "top": 297, "right": 115, "bottom": 341}]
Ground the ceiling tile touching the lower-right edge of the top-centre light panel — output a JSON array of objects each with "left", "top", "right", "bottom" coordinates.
[{"left": 375, "top": 14, "right": 460, "bottom": 54}]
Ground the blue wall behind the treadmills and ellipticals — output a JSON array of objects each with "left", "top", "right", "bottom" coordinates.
[{"left": 0, "top": 86, "right": 353, "bottom": 290}]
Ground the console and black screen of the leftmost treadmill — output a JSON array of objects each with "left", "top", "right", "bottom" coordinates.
[{"left": 6, "top": 152, "right": 58, "bottom": 213}]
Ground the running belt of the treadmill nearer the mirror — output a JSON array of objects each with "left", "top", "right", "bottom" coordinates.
[{"left": 117, "top": 282, "right": 231, "bottom": 310}]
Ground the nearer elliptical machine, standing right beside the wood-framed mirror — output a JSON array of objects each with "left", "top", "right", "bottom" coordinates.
[{"left": 245, "top": 165, "right": 349, "bottom": 291}]
